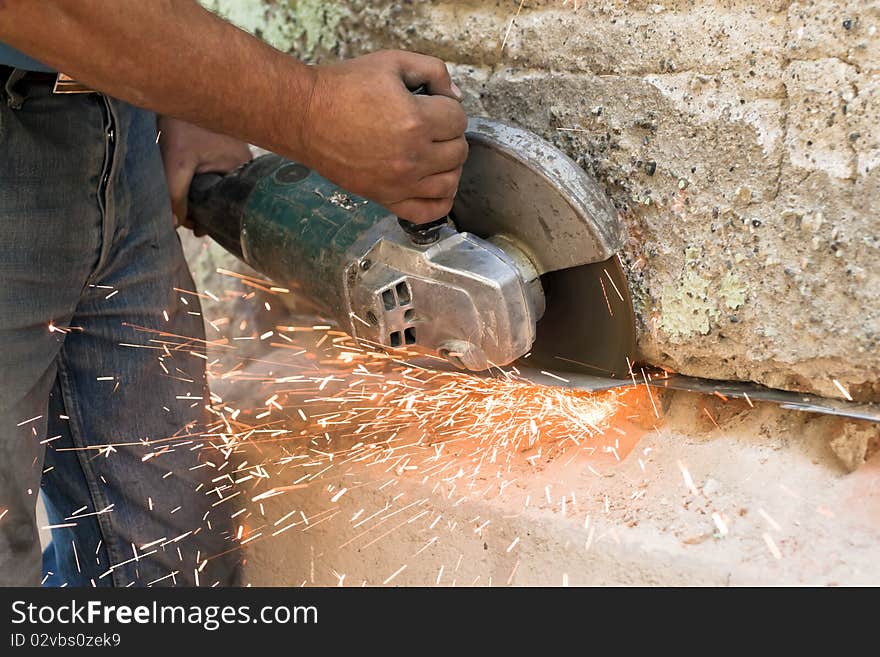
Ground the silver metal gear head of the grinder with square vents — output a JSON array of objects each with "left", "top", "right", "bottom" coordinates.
[{"left": 340, "top": 217, "right": 544, "bottom": 371}]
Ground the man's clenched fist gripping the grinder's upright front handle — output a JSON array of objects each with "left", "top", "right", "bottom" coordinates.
[{"left": 300, "top": 51, "right": 468, "bottom": 223}]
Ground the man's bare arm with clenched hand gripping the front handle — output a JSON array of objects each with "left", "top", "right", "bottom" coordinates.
[{"left": 0, "top": 0, "right": 468, "bottom": 222}]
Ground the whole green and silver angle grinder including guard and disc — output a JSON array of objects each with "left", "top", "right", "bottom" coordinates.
[{"left": 189, "top": 118, "right": 635, "bottom": 376}]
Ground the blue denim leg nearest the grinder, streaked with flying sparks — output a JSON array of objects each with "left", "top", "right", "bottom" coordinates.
[{"left": 44, "top": 100, "right": 239, "bottom": 586}]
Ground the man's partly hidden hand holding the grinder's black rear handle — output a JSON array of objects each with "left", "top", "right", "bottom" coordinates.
[{"left": 159, "top": 116, "right": 253, "bottom": 229}]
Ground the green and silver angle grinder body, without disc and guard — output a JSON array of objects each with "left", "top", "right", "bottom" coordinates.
[{"left": 190, "top": 154, "right": 544, "bottom": 370}]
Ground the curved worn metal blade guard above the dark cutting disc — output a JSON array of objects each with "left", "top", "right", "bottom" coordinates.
[{"left": 452, "top": 118, "right": 624, "bottom": 274}]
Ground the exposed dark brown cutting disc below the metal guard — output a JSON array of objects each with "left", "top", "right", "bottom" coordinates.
[{"left": 521, "top": 256, "right": 636, "bottom": 378}]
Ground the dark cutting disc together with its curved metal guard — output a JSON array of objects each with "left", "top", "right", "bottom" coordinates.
[{"left": 453, "top": 118, "right": 635, "bottom": 378}]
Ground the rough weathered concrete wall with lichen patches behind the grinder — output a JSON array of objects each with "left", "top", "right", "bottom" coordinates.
[{"left": 206, "top": 0, "right": 880, "bottom": 399}]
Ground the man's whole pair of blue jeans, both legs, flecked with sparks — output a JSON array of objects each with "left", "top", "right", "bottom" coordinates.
[{"left": 0, "top": 75, "right": 239, "bottom": 586}]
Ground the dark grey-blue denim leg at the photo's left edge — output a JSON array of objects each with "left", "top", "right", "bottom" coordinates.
[{"left": 0, "top": 86, "right": 105, "bottom": 586}]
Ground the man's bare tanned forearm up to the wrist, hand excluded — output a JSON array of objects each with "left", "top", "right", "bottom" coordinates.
[{"left": 0, "top": 0, "right": 314, "bottom": 159}]
